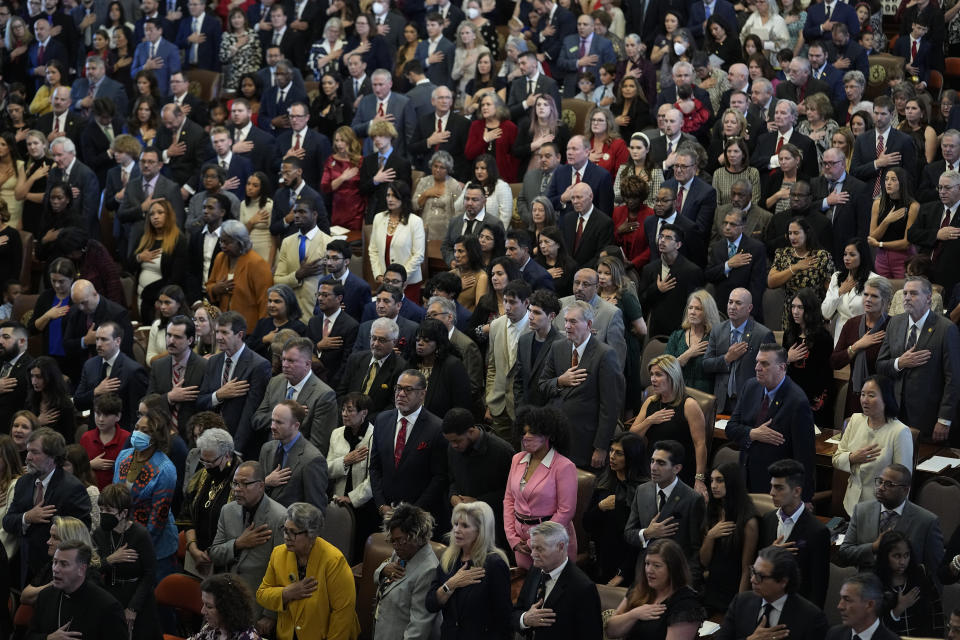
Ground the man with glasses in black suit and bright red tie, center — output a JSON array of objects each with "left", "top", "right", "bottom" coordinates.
[{"left": 369, "top": 369, "right": 449, "bottom": 529}]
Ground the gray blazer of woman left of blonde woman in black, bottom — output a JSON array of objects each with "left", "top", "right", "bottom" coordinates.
[{"left": 373, "top": 544, "right": 440, "bottom": 640}]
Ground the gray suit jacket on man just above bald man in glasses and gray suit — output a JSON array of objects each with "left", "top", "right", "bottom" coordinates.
[{"left": 260, "top": 433, "right": 327, "bottom": 512}]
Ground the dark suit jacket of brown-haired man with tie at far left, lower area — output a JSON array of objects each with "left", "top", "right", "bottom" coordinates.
[{"left": 3, "top": 467, "right": 90, "bottom": 584}]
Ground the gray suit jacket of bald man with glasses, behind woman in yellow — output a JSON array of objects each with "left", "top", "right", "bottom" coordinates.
[{"left": 207, "top": 495, "right": 287, "bottom": 618}]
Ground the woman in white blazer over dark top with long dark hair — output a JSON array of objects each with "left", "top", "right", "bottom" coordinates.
[{"left": 367, "top": 181, "right": 427, "bottom": 302}]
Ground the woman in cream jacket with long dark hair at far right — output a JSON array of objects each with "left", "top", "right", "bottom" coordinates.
[{"left": 832, "top": 375, "right": 913, "bottom": 515}]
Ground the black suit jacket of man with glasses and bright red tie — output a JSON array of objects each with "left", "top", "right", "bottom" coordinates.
[{"left": 370, "top": 408, "right": 449, "bottom": 522}]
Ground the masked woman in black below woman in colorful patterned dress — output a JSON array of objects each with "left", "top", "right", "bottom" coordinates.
[{"left": 93, "top": 484, "right": 163, "bottom": 640}]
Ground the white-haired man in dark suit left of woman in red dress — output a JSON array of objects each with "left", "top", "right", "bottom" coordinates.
[{"left": 407, "top": 85, "right": 471, "bottom": 182}]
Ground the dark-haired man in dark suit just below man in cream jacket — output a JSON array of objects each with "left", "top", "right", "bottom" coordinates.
[{"left": 307, "top": 277, "right": 360, "bottom": 388}]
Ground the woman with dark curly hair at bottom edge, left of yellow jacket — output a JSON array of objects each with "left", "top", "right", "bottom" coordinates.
[{"left": 188, "top": 573, "right": 260, "bottom": 640}]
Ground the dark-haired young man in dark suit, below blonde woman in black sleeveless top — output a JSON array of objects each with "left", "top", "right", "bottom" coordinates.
[{"left": 623, "top": 440, "right": 706, "bottom": 570}]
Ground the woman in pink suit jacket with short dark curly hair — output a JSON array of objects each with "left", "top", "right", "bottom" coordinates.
[{"left": 503, "top": 407, "right": 577, "bottom": 569}]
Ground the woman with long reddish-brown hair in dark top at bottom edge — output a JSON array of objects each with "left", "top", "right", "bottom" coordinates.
[{"left": 604, "top": 538, "right": 706, "bottom": 640}]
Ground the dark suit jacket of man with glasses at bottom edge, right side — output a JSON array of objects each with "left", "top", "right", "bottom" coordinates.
[{"left": 713, "top": 591, "right": 828, "bottom": 640}]
